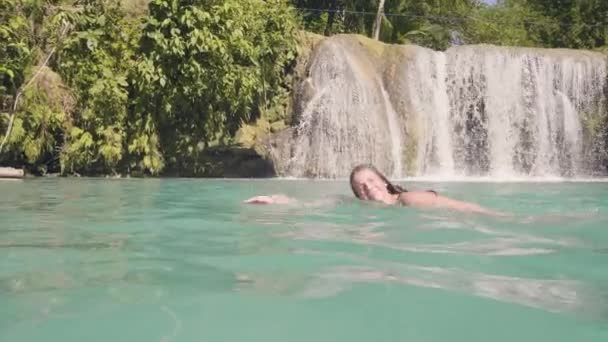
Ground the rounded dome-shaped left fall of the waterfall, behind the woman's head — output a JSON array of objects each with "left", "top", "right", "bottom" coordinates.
[{"left": 288, "top": 37, "right": 402, "bottom": 178}]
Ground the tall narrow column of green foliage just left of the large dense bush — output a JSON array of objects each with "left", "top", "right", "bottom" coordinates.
[{"left": 54, "top": 0, "right": 137, "bottom": 173}]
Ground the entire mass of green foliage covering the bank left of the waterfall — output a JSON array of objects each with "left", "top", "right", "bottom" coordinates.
[{"left": 0, "top": 0, "right": 297, "bottom": 174}]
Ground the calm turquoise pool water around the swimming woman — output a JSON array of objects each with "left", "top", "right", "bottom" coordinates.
[{"left": 0, "top": 179, "right": 608, "bottom": 342}]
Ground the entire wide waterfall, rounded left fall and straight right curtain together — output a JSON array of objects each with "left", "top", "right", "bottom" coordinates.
[{"left": 279, "top": 36, "right": 608, "bottom": 178}]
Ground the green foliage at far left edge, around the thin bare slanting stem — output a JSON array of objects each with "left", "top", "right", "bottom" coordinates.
[{"left": 0, "top": 0, "right": 65, "bottom": 172}]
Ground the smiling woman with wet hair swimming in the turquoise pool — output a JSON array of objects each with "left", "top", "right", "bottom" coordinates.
[{"left": 245, "top": 165, "right": 505, "bottom": 216}]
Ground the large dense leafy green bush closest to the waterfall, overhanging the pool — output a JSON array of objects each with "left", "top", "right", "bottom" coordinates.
[{"left": 131, "top": 0, "right": 296, "bottom": 172}]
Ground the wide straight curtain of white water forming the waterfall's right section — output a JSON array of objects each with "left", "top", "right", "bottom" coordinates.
[{"left": 446, "top": 46, "right": 607, "bottom": 177}]
